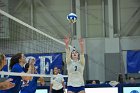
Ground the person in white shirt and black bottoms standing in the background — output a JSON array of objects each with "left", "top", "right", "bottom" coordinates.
[{"left": 50, "top": 67, "right": 65, "bottom": 93}]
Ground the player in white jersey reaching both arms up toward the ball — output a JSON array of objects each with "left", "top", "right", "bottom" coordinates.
[{"left": 64, "top": 37, "right": 85, "bottom": 93}]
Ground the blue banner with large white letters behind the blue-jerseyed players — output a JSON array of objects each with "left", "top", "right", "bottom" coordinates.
[{"left": 6, "top": 53, "right": 63, "bottom": 74}]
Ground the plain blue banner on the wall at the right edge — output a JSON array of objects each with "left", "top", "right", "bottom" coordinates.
[{"left": 127, "top": 50, "right": 140, "bottom": 73}]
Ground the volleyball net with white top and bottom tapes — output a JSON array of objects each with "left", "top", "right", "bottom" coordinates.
[{"left": 0, "top": 9, "right": 71, "bottom": 77}]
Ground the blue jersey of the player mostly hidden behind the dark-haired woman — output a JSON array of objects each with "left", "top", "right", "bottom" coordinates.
[{"left": 20, "top": 77, "right": 38, "bottom": 93}]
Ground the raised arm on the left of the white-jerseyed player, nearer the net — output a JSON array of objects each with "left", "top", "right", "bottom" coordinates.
[{"left": 64, "top": 37, "right": 71, "bottom": 63}]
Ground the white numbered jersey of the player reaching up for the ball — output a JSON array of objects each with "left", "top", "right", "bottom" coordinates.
[{"left": 67, "top": 60, "right": 84, "bottom": 87}]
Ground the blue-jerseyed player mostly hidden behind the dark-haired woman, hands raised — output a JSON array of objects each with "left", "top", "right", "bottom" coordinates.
[{"left": 20, "top": 58, "right": 45, "bottom": 93}]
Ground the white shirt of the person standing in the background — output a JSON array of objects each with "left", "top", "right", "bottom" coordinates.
[{"left": 51, "top": 74, "right": 64, "bottom": 90}]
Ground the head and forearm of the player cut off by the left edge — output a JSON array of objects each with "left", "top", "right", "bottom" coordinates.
[{"left": 0, "top": 54, "right": 15, "bottom": 90}]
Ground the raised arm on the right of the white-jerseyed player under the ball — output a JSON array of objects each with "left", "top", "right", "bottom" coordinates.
[{"left": 79, "top": 38, "right": 85, "bottom": 65}]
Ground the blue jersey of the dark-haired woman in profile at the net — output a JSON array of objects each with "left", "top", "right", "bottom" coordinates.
[{"left": 2, "top": 63, "right": 24, "bottom": 93}]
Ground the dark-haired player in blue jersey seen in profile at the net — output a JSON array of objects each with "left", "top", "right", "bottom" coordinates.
[{"left": 0, "top": 53, "right": 33, "bottom": 93}]
